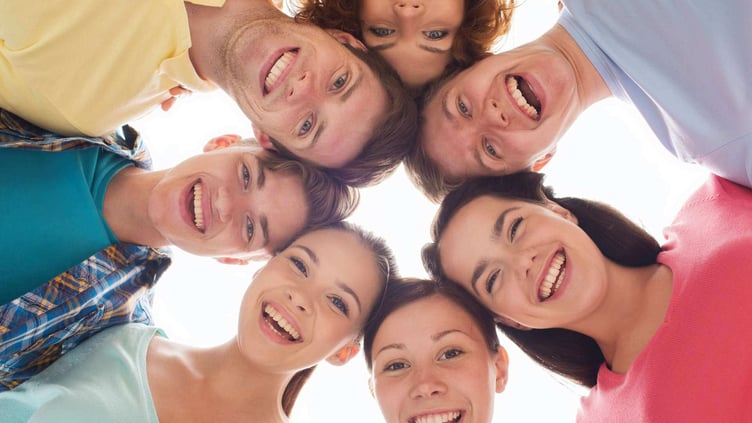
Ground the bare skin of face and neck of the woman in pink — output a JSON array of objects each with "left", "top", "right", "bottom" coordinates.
[{"left": 439, "top": 196, "right": 673, "bottom": 373}]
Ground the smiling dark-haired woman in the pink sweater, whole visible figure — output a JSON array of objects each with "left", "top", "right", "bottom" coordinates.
[{"left": 423, "top": 172, "right": 752, "bottom": 422}]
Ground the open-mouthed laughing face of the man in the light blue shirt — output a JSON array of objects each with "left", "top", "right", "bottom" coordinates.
[{"left": 420, "top": 44, "right": 584, "bottom": 180}]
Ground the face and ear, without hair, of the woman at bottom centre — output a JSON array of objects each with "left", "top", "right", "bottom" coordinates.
[{"left": 371, "top": 295, "right": 507, "bottom": 423}]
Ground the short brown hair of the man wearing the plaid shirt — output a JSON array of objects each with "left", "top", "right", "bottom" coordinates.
[{"left": 250, "top": 139, "right": 360, "bottom": 247}]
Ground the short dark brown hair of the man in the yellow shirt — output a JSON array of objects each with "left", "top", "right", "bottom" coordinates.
[{"left": 270, "top": 45, "right": 418, "bottom": 188}]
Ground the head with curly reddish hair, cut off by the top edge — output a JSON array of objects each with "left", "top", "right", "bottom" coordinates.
[{"left": 296, "top": 0, "right": 514, "bottom": 88}]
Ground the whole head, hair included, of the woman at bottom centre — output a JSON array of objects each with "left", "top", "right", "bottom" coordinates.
[{"left": 364, "top": 279, "right": 507, "bottom": 423}]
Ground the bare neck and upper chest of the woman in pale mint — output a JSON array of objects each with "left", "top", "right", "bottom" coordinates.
[{"left": 147, "top": 338, "right": 293, "bottom": 423}]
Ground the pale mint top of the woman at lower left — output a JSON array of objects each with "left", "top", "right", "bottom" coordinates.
[{"left": 0, "top": 323, "right": 164, "bottom": 423}]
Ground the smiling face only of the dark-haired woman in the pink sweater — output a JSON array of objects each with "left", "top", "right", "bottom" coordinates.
[{"left": 439, "top": 196, "right": 608, "bottom": 329}]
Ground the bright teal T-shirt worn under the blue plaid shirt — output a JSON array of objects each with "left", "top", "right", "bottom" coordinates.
[{"left": 0, "top": 147, "right": 132, "bottom": 304}]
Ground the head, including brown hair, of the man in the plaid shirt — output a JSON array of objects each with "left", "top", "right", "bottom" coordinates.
[{"left": 148, "top": 137, "right": 359, "bottom": 259}]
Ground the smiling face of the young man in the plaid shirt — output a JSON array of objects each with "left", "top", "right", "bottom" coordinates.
[{"left": 148, "top": 147, "right": 308, "bottom": 258}]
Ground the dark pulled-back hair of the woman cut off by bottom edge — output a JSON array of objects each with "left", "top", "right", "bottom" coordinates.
[{"left": 363, "top": 278, "right": 500, "bottom": 370}]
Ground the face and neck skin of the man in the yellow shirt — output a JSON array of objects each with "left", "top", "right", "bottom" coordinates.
[{"left": 186, "top": 0, "right": 387, "bottom": 168}]
